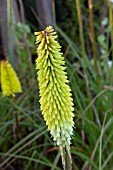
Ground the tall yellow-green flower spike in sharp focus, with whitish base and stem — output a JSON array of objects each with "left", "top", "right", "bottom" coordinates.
[{"left": 35, "top": 26, "right": 74, "bottom": 169}]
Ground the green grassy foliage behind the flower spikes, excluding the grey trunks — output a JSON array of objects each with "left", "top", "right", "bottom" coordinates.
[{"left": 0, "top": 0, "right": 113, "bottom": 170}]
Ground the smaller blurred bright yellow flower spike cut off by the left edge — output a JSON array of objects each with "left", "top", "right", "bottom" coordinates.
[{"left": 0, "top": 60, "right": 22, "bottom": 97}]
